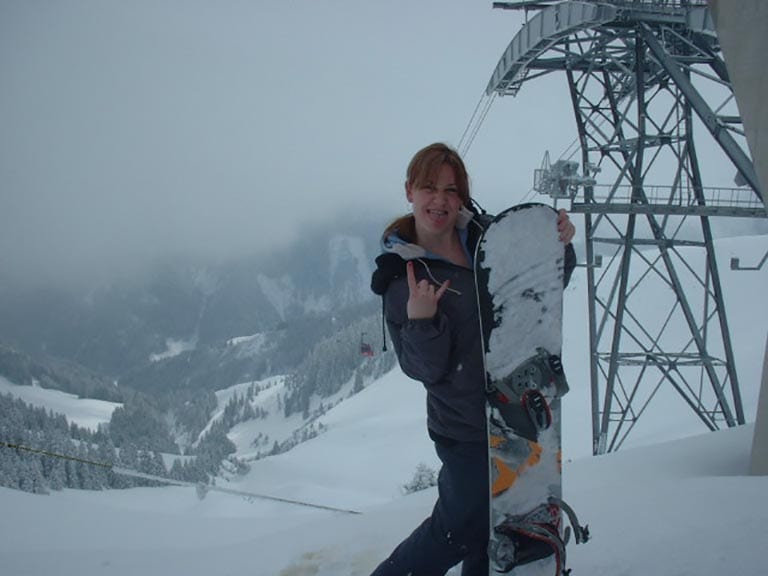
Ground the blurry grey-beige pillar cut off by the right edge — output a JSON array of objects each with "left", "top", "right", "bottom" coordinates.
[{"left": 709, "top": 0, "right": 768, "bottom": 475}]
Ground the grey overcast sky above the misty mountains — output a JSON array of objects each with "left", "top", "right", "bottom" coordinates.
[{"left": 0, "top": 0, "right": 584, "bottom": 288}]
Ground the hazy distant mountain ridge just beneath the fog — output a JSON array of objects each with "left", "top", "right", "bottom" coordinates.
[{"left": 0, "top": 220, "right": 382, "bottom": 382}]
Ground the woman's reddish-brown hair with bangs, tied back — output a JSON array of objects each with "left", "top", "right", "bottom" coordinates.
[{"left": 383, "top": 142, "right": 472, "bottom": 243}]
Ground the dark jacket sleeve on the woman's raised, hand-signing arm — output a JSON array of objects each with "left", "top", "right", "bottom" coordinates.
[{"left": 385, "top": 284, "right": 451, "bottom": 386}]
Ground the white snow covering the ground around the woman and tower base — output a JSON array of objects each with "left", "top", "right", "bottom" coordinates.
[{"left": 0, "top": 237, "right": 768, "bottom": 576}]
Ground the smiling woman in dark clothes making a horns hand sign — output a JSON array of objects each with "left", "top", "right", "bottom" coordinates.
[{"left": 371, "top": 143, "right": 575, "bottom": 576}]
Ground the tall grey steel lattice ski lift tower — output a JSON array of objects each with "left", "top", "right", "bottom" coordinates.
[{"left": 486, "top": 0, "right": 765, "bottom": 454}]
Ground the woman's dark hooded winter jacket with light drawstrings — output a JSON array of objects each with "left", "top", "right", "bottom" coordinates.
[{"left": 371, "top": 216, "right": 575, "bottom": 442}]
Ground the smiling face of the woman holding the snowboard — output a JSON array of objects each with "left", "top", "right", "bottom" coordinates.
[{"left": 405, "top": 164, "right": 462, "bottom": 235}]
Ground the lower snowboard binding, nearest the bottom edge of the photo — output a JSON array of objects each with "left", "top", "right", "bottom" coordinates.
[{"left": 489, "top": 497, "right": 590, "bottom": 576}]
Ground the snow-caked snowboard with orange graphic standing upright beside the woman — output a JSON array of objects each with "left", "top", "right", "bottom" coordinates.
[{"left": 475, "top": 203, "right": 588, "bottom": 576}]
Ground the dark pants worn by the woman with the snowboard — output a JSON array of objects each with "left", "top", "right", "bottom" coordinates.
[{"left": 371, "top": 441, "right": 489, "bottom": 576}]
